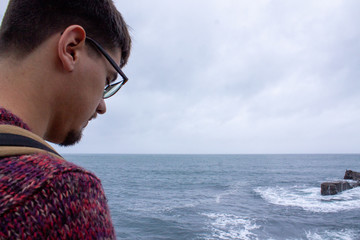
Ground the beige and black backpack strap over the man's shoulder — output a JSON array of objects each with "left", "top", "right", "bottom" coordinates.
[{"left": 0, "top": 125, "right": 62, "bottom": 158}]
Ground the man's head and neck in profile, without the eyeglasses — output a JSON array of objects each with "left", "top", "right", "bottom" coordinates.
[{"left": 0, "top": 0, "right": 131, "bottom": 145}]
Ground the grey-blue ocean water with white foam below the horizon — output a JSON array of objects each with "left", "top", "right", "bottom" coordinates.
[{"left": 65, "top": 155, "right": 360, "bottom": 240}]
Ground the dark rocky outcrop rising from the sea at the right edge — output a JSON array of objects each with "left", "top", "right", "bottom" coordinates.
[{"left": 321, "top": 170, "right": 360, "bottom": 195}]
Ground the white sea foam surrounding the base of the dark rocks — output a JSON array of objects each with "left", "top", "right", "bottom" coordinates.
[{"left": 254, "top": 186, "right": 360, "bottom": 213}]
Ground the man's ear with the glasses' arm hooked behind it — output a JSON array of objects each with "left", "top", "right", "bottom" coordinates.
[{"left": 58, "top": 25, "right": 86, "bottom": 72}]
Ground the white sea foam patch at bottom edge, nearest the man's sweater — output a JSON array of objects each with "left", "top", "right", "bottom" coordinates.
[{"left": 204, "top": 213, "right": 259, "bottom": 240}]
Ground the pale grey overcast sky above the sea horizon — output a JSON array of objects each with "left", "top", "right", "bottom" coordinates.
[{"left": 0, "top": 0, "right": 360, "bottom": 153}]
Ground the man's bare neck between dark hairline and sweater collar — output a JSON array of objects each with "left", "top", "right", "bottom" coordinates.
[{"left": 0, "top": 53, "right": 52, "bottom": 138}]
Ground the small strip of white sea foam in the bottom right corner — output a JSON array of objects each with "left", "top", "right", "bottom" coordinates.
[{"left": 306, "top": 229, "right": 359, "bottom": 240}]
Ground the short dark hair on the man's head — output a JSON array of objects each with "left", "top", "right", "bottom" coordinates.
[{"left": 0, "top": 0, "right": 131, "bottom": 66}]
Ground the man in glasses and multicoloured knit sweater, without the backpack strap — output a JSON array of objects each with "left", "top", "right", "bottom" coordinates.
[{"left": 0, "top": 0, "right": 131, "bottom": 239}]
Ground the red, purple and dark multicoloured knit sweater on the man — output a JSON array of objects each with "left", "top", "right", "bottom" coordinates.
[{"left": 0, "top": 108, "right": 115, "bottom": 239}]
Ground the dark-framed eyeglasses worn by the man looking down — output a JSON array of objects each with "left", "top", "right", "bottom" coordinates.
[{"left": 86, "top": 37, "right": 129, "bottom": 99}]
